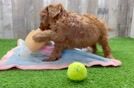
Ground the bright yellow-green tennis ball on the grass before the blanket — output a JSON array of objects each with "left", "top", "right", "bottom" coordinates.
[{"left": 67, "top": 62, "right": 87, "bottom": 81}]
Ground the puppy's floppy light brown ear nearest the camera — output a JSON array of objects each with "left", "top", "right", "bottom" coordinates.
[{"left": 48, "top": 4, "right": 64, "bottom": 18}]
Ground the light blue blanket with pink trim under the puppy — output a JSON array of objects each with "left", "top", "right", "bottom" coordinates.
[{"left": 0, "top": 39, "right": 121, "bottom": 70}]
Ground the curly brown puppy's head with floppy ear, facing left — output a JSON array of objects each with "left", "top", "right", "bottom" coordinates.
[{"left": 40, "top": 4, "right": 64, "bottom": 30}]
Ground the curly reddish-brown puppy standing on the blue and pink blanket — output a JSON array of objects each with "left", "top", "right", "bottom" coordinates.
[{"left": 33, "top": 4, "right": 113, "bottom": 60}]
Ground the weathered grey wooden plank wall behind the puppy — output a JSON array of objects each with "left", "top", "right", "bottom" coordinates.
[{"left": 0, "top": 0, "right": 134, "bottom": 38}]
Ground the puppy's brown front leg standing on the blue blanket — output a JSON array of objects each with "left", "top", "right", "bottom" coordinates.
[{"left": 47, "top": 45, "right": 63, "bottom": 61}]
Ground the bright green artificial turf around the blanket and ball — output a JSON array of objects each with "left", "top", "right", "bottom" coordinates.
[{"left": 0, "top": 38, "right": 134, "bottom": 88}]
